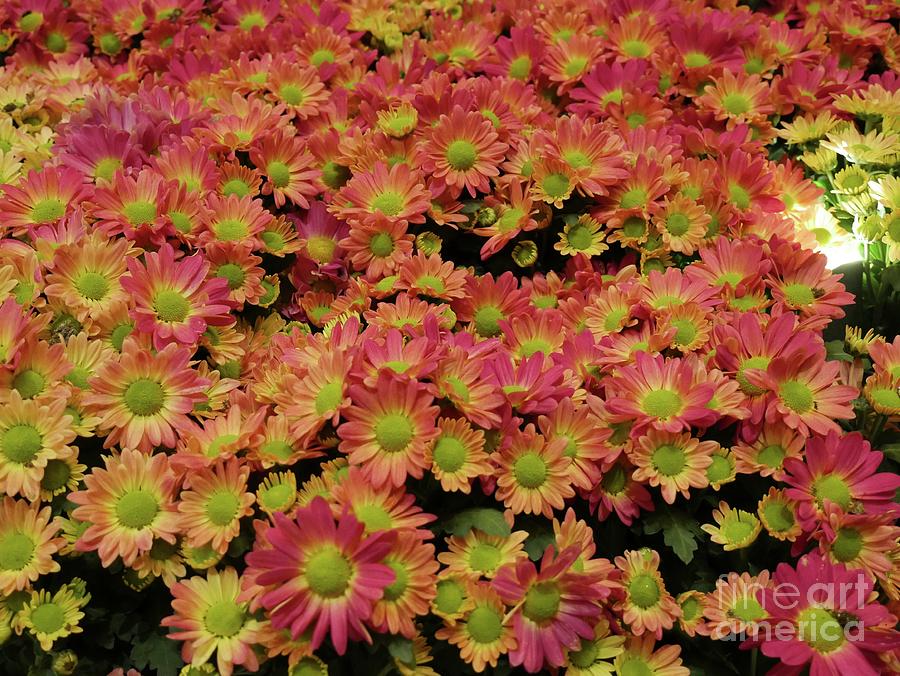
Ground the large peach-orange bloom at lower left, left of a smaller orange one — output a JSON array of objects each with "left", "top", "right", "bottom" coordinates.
[{"left": 69, "top": 450, "right": 178, "bottom": 568}]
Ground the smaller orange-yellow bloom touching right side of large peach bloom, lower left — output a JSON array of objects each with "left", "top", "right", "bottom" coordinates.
[{"left": 178, "top": 458, "right": 253, "bottom": 554}]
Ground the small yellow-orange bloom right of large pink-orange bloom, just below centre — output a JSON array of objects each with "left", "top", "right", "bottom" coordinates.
[{"left": 425, "top": 418, "right": 493, "bottom": 493}]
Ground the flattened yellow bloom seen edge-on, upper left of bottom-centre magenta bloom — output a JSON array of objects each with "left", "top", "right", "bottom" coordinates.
[{"left": 438, "top": 528, "right": 528, "bottom": 581}]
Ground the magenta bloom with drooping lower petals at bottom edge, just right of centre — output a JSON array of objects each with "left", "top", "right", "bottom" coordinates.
[{"left": 492, "top": 547, "right": 601, "bottom": 673}]
